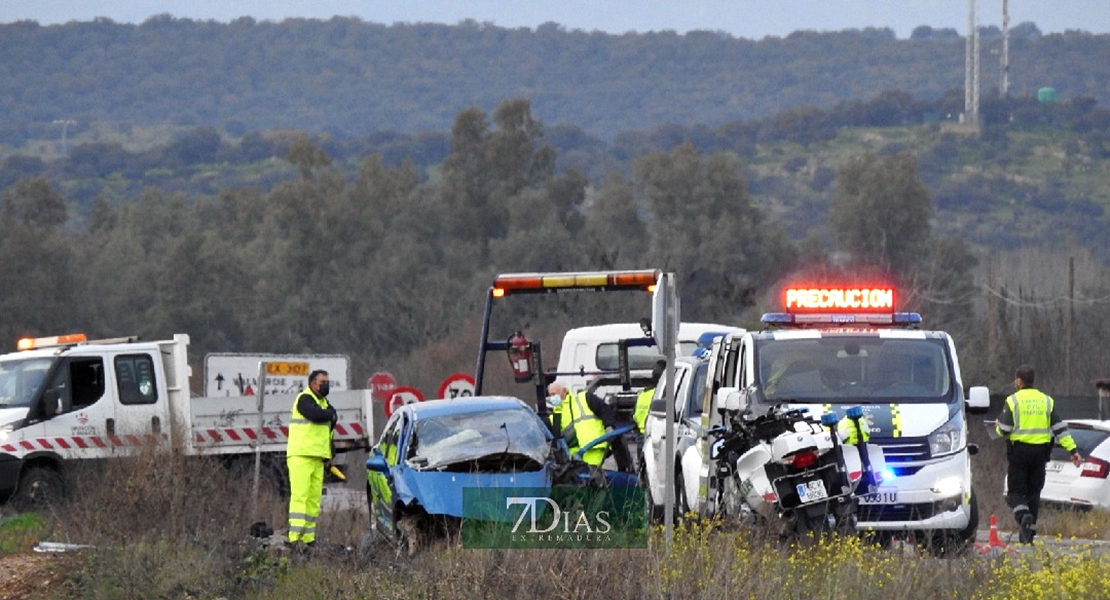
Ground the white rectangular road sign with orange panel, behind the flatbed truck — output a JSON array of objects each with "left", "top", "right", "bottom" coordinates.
[{"left": 204, "top": 353, "right": 351, "bottom": 397}]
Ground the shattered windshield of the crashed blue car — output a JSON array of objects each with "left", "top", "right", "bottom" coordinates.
[{"left": 408, "top": 406, "right": 548, "bottom": 469}]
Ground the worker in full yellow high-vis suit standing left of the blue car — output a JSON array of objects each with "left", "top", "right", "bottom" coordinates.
[{"left": 285, "top": 370, "right": 336, "bottom": 547}]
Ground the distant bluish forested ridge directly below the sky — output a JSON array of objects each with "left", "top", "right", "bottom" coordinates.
[{"left": 0, "top": 16, "right": 1110, "bottom": 140}]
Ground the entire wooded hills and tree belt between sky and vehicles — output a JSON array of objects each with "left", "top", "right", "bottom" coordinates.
[{"left": 0, "top": 18, "right": 1110, "bottom": 394}]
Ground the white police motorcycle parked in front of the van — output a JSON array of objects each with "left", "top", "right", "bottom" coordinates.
[{"left": 710, "top": 407, "right": 881, "bottom": 536}]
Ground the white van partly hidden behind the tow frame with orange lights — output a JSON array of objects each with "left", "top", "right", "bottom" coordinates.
[{"left": 555, "top": 323, "right": 744, "bottom": 390}]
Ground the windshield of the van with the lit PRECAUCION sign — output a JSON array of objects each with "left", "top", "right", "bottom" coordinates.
[{"left": 756, "top": 335, "right": 952, "bottom": 404}]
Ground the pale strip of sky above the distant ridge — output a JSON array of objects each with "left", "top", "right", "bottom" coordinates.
[{"left": 0, "top": 0, "right": 1110, "bottom": 39}]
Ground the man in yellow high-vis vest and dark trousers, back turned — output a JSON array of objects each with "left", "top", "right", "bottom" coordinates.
[{"left": 998, "top": 365, "right": 1083, "bottom": 543}]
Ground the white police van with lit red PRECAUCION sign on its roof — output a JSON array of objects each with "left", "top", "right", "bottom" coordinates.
[{"left": 702, "top": 287, "right": 990, "bottom": 549}]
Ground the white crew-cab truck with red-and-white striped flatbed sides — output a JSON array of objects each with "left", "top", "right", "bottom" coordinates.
[{"left": 0, "top": 334, "right": 374, "bottom": 505}]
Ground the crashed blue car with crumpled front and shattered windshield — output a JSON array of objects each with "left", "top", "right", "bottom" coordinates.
[{"left": 366, "top": 397, "right": 565, "bottom": 553}]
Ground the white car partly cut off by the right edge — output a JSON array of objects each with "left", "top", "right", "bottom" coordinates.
[{"left": 1041, "top": 419, "right": 1110, "bottom": 508}]
